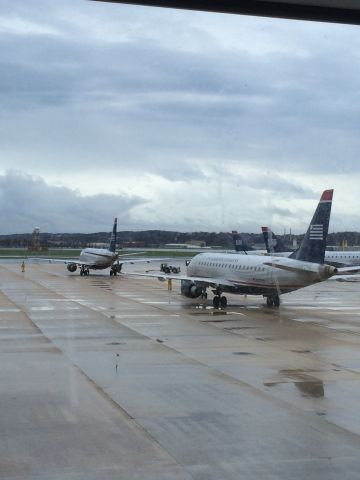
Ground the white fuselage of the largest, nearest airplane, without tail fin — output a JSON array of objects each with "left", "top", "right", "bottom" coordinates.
[{"left": 187, "top": 253, "right": 336, "bottom": 295}]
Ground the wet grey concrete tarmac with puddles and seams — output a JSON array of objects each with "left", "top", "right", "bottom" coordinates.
[{"left": 0, "top": 263, "right": 360, "bottom": 480}]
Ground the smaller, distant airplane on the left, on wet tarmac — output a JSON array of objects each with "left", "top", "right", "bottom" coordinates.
[{"left": 37, "top": 218, "right": 150, "bottom": 276}]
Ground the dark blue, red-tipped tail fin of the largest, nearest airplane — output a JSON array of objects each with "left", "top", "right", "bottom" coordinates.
[{"left": 290, "top": 190, "right": 334, "bottom": 263}]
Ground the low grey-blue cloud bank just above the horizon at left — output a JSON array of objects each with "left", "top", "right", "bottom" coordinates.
[{"left": 0, "top": 171, "right": 142, "bottom": 234}]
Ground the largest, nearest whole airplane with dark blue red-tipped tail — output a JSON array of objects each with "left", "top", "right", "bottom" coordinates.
[{"left": 126, "top": 190, "right": 354, "bottom": 308}]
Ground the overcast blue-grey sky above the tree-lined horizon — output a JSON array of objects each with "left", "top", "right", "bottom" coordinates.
[{"left": 0, "top": 0, "right": 360, "bottom": 234}]
